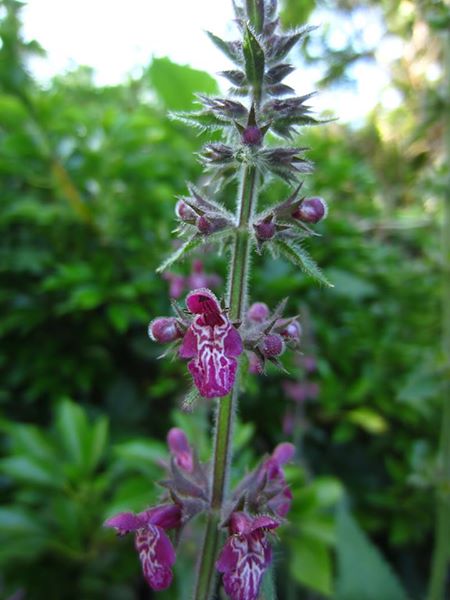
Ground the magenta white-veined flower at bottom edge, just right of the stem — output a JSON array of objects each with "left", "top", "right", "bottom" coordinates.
[{"left": 216, "top": 512, "right": 280, "bottom": 600}]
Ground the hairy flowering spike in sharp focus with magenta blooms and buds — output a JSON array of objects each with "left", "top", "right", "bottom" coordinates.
[{"left": 106, "top": 0, "right": 328, "bottom": 600}]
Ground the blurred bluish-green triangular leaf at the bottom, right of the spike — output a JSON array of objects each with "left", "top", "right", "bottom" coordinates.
[{"left": 336, "top": 507, "right": 407, "bottom": 600}]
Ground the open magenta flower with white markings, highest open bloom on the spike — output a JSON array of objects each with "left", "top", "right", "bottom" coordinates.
[{"left": 179, "top": 288, "right": 243, "bottom": 398}]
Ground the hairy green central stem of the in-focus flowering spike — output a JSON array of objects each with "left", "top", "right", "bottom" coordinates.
[{"left": 194, "top": 165, "right": 257, "bottom": 600}]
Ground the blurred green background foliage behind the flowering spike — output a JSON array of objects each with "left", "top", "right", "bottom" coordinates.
[{"left": 0, "top": 0, "right": 442, "bottom": 600}]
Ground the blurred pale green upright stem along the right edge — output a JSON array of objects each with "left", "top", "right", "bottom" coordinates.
[{"left": 428, "top": 25, "right": 450, "bottom": 600}]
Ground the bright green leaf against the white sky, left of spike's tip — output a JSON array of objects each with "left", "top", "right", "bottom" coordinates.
[{"left": 148, "top": 58, "right": 218, "bottom": 111}]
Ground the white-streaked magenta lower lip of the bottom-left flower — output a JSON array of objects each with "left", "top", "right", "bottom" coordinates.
[{"left": 136, "top": 525, "right": 175, "bottom": 591}]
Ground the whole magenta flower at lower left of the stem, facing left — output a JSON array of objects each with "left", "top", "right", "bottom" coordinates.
[{"left": 105, "top": 504, "right": 181, "bottom": 591}]
